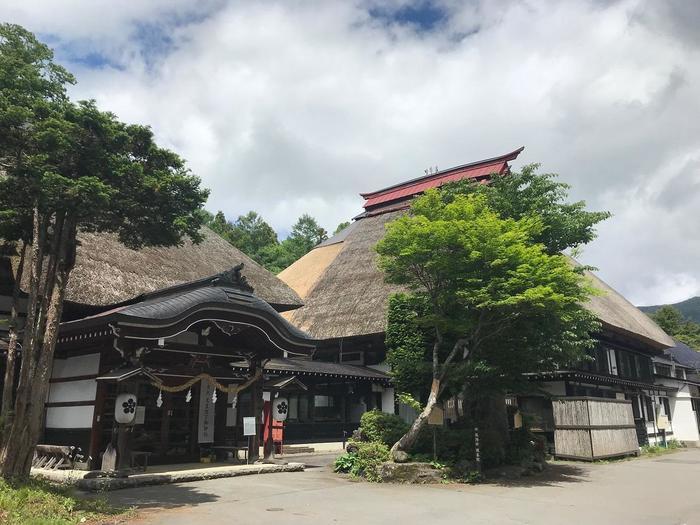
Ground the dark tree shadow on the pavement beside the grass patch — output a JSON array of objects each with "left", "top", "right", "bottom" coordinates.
[{"left": 83, "top": 483, "right": 219, "bottom": 510}]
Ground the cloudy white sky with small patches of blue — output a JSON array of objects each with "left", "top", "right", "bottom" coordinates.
[{"left": 0, "top": 0, "right": 700, "bottom": 304}]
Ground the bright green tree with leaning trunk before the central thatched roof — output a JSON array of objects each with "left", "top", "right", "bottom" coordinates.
[{"left": 376, "top": 190, "right": 599, "bottom": 453}]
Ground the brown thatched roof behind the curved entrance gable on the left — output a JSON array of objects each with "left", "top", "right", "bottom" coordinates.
[{"left": 9, "top": 228, "right": 301, "bottom": 310}]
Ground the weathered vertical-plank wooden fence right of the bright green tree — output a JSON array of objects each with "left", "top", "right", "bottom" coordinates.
[{"left": 552, "top": 397, "right": 639, "bottom": 461}]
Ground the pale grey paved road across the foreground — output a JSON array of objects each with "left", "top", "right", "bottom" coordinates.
[{"left": 105, "top": 449, "right": 700, "bottom": 525}]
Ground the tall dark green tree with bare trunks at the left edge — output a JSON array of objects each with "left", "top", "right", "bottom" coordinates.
[{"left": 0, "top": 26, "right": 208, "bottom": 477}]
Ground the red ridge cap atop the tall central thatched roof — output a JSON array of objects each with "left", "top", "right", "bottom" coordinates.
[{"left": 360, "top": 146, "right": 525, "bottom": 210}]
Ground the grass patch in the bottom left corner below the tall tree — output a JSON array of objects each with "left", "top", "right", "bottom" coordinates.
[{"left": 0, "top": 479, "right": 133, "bottom": 525}]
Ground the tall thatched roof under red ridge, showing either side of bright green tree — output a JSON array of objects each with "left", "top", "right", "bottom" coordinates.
[{"left": 279, "top": 211, "right": 674, "bottom": 348}]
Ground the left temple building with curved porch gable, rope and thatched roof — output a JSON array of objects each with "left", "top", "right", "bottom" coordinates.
[{"left": 0, "top": 229, "right": 394, "bottom": 468}]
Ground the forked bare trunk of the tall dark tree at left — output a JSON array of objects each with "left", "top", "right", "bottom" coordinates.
[{"left": 0, "top": 213, "right": 76, "bottom": 479}]
